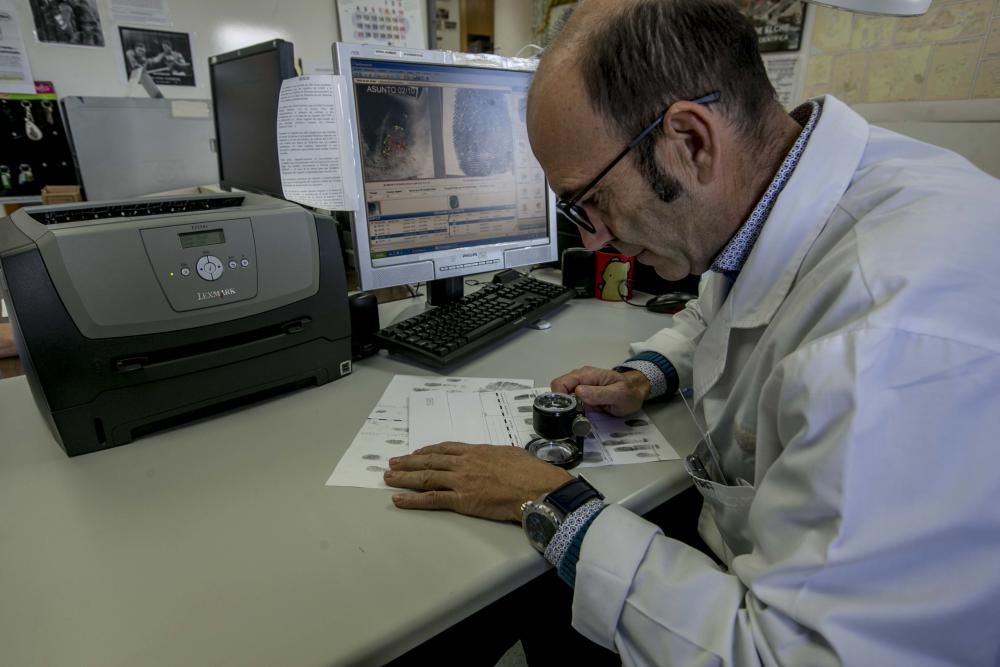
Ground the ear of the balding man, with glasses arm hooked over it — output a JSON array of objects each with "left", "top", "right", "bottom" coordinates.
[{"left": 662, "top": 101, "right": 722, "bottom": 185}]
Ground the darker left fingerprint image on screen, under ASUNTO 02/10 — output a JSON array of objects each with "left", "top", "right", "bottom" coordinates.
[{"left": 355, "top": 84, "right": 434, "bottom": 181}]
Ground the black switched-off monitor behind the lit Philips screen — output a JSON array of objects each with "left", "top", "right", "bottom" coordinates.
[{"left": 208, "top": 39, "right": 295, "bottom": 197}]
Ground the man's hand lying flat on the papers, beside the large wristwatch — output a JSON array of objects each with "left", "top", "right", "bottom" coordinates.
[{"left": 385, "top": 442, "right": 572, "bottom": 521}]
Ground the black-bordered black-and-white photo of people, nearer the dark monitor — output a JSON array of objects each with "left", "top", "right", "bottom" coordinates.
[{"left": 118, "top": 27, "right": 195, "bottom": 86}]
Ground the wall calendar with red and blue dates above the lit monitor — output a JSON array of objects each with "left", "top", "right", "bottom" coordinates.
[{"left": 337, "top": 0, "right": 427, "bottom": 49}]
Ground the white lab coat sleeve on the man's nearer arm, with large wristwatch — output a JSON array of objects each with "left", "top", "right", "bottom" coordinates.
[{"left": 573, "top": 329, "right": 1000, "bottom": 666}]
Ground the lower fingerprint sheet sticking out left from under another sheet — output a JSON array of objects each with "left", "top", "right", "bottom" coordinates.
[{"left": 326, "top": 375, "right": 534, "bottom": 489}]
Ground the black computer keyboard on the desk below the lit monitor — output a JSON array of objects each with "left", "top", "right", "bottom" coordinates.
[{"left": 375, "top": 276, "right": 575, "bottom": 368}]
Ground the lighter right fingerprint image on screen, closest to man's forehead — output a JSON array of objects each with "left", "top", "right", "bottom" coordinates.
[{"left": 444, "top": 88, "right": 514, "bottom": 176}]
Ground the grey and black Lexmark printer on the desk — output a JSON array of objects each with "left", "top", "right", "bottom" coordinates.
[{"left": 0, "top": 194, "right": 351, "bottom": 456}]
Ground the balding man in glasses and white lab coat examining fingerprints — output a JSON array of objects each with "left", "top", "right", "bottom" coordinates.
[{"left": 386, "top": 0, "right": 1000, "bottom": 665}]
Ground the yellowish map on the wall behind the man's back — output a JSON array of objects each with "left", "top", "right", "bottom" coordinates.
[{"left": 804, "top": 0, "right": 1000, "bottom": 104}]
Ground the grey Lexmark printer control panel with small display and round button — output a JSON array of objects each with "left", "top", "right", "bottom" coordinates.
[{"left": 141, "top": 219, "right": 257, "bottom": 311}]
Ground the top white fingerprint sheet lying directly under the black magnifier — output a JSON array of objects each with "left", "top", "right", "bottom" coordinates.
[{"left": 409, "top": 389, "right": 680, "bottom": 467}]
